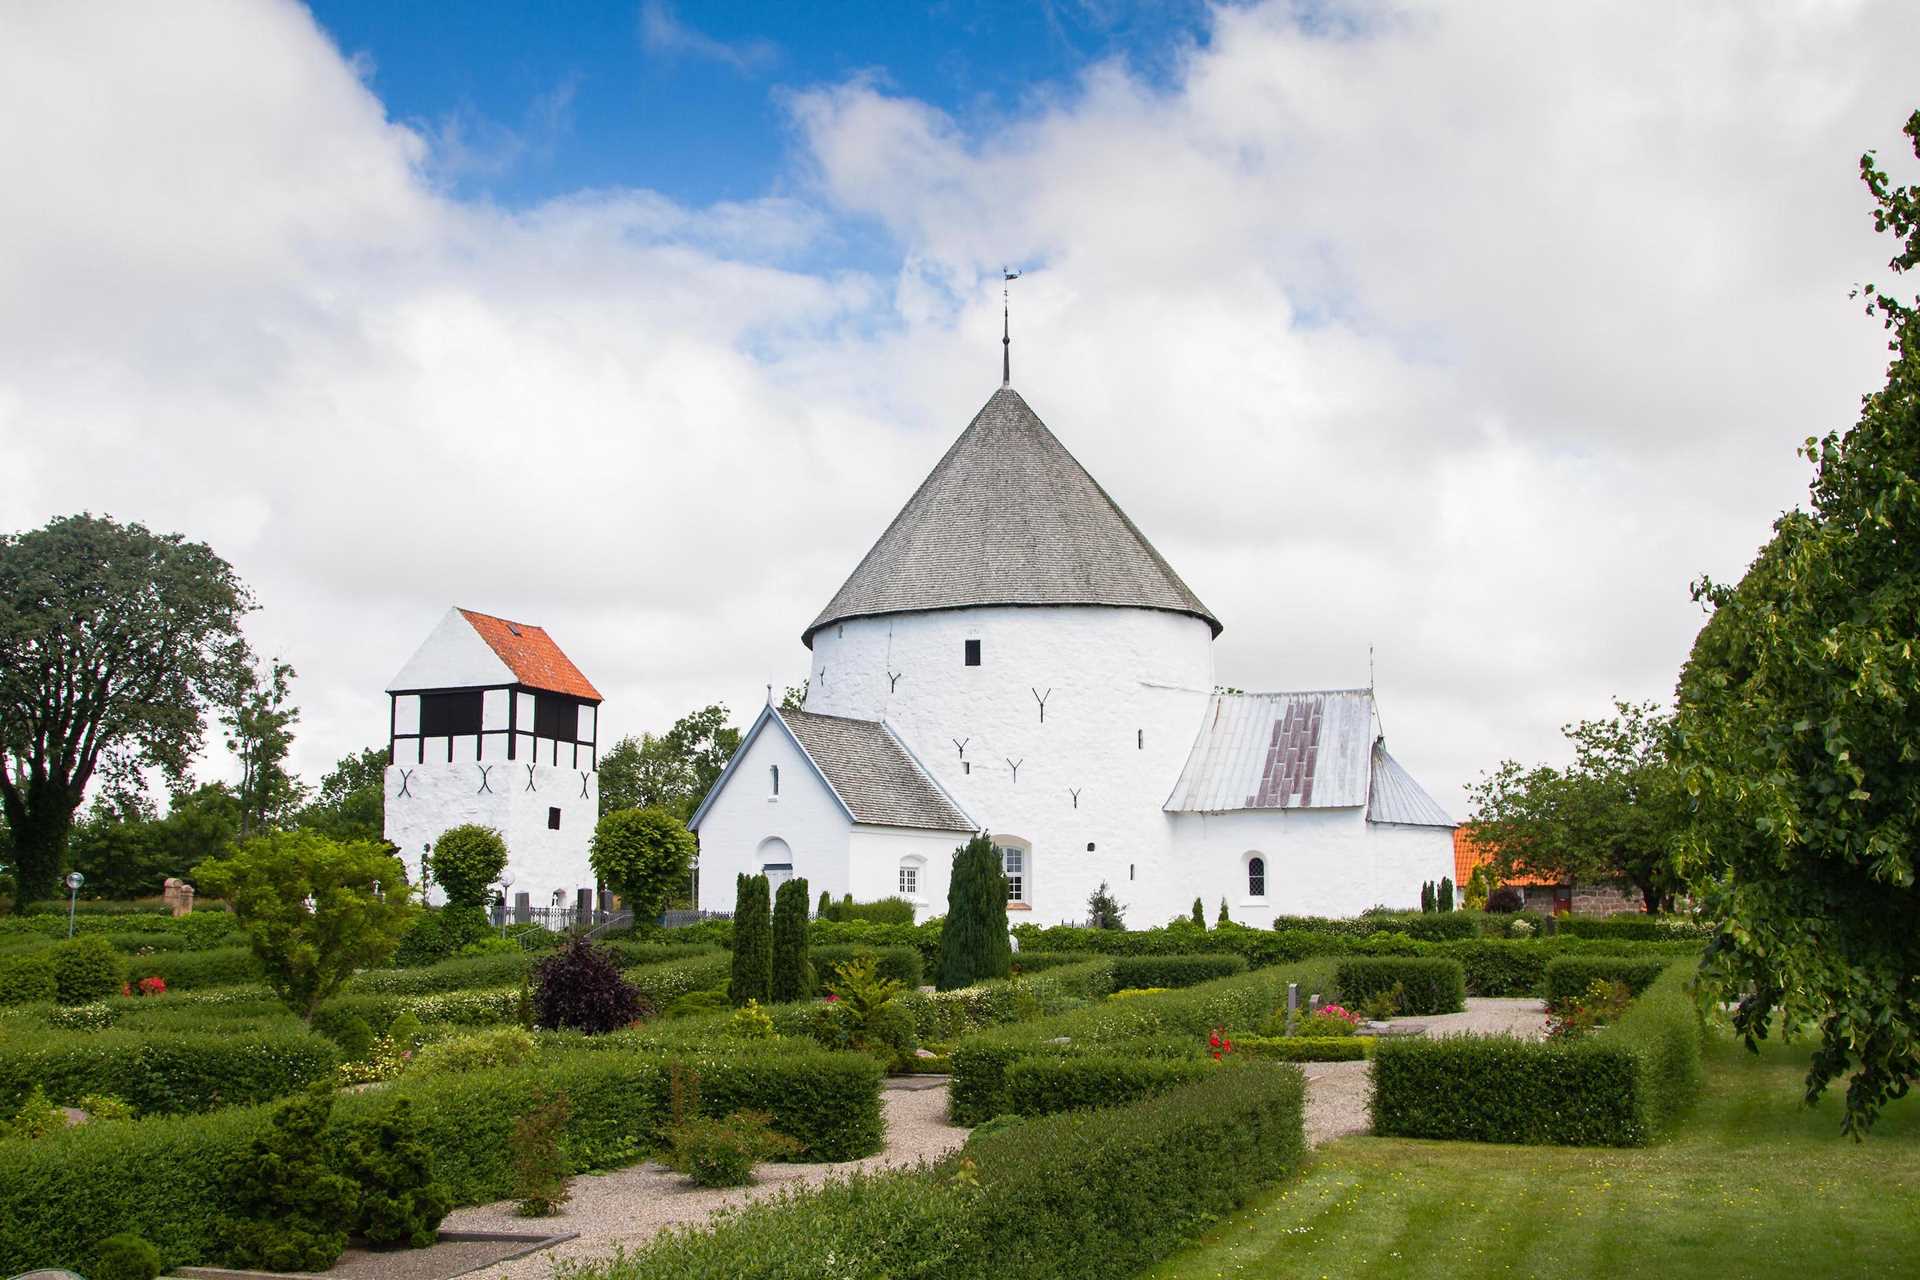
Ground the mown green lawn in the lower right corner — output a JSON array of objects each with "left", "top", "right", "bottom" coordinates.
[{"left": 1148, "top": 1042, "right": 1920, "bottom": 1280}]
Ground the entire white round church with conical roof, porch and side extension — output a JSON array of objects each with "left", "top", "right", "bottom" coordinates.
[{"left": 691, "top": 364, "right": 1453, "bottom": 927}]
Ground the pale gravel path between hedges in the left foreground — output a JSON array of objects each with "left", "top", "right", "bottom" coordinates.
[{"left": 444, "top": 1077, "right": 968, "bottom": 1280}]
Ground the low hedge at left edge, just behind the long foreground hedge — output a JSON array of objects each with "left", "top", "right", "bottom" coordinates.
[{"left": 0, "top": 1029, "right": 340, "bottom": 1115}]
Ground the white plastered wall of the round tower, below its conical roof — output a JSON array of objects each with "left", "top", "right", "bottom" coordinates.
[{"left": 806, "top": 606, "right": 1213, "bottom": 923}]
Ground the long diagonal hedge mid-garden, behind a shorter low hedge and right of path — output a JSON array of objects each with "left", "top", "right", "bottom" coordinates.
[{"left": 947, "top": 961, "right": 1332, "bottom": 1125}]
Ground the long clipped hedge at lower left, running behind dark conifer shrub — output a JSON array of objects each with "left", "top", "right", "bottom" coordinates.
[{"left": 0, "top": 1050, "right": 883, "bottom": 1274}]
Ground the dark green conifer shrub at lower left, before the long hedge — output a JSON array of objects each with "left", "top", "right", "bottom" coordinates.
[{"left": 221, "top": 1086, "right": 359, "bottom": 1270}]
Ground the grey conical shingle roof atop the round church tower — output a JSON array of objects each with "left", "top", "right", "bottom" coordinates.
[{"left": 801, "top": 386, "right": 1221, "bottom": 649}]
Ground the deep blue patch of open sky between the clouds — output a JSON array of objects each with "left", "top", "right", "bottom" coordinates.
[{"left": 313, "top": 0, "right": 1206, "bottom": 207}]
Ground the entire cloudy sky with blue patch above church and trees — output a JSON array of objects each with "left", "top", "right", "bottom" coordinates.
[{"left": 0, "top": 0, "right": 1920, "bottom": 814}]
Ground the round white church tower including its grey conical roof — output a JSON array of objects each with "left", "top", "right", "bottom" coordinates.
[{"left": 801, "top": 386, "right": 1221, "bottom": 923}]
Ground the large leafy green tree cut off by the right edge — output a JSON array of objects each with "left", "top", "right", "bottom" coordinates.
[{"left": 1676, "top": 111, "right": 1920, "bottom": 1136}]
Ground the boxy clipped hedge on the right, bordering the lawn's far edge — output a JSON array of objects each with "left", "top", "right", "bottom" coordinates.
[{"left": 1373, "top": 965, "right": 1701, "bottom": 1146}]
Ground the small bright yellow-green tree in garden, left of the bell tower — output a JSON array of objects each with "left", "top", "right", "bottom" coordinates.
[{"left": 194, "top": 831, "right": 419, "bottom": 1021}]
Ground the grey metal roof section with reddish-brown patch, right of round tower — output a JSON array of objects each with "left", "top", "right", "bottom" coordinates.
[{"left": 1165, "top": 689, "right": 1373, "bottom": 814}]
